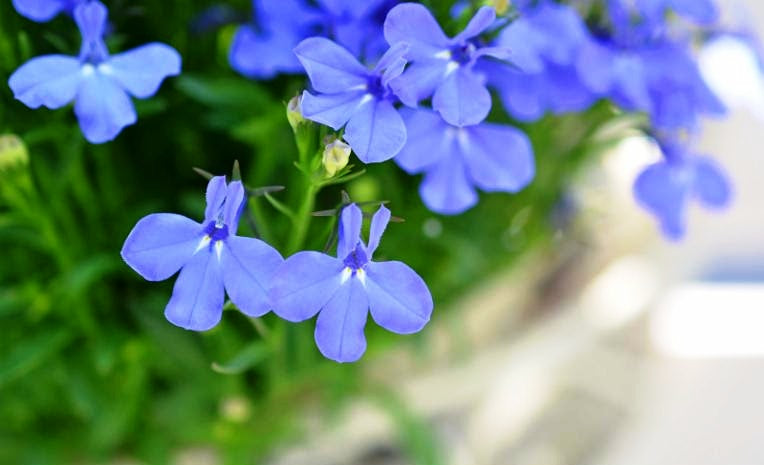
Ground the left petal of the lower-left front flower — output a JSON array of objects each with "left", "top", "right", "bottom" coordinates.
[{"left": 121, "top": 213, "right": 204, "bottom": 281}]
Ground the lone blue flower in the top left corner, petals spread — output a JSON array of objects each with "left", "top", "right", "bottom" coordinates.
[{"left": 8, "top": 1, "right": 181, "bottom": 143}]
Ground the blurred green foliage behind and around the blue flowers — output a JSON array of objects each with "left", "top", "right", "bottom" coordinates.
[{"left": 0, "top": 0, "right": 615, "bottom": 464}]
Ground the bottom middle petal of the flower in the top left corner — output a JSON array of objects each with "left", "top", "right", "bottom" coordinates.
[{"left": 74, "top": 72, "right": 137, "bottom": 144}]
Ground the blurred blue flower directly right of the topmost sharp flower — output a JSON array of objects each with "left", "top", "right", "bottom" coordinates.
[{"left": 480, "top": 1, "right": 598, "bottom": 121}]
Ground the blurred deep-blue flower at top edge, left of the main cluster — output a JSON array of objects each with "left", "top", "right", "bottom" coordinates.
[{"left": 229, "top": 0, "right": 398, "bottom": 79}]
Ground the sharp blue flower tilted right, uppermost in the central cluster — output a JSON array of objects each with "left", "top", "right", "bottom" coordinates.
[{"left": 384, "top": 3, "right": 509, "bottom": 126}]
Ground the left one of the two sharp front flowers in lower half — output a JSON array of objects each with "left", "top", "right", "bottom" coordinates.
[{"left": 122, "top": 176, "right": 283, "bottom": 331}]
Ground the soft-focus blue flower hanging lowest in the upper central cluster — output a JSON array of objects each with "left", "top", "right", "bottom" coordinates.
[{"left": 395, "top": 109, "right": 535, "bottom": 215}]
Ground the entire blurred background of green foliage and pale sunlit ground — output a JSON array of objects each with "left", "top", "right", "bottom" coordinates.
[{"left": 0, "top": 0, "right": 764, "bottom": 465}]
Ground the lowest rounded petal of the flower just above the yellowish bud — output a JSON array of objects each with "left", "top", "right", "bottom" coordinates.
[{"left": 345, "top": 100, "right": 406, "bottom": 163}]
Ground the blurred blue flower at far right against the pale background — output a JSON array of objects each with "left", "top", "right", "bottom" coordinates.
[{"left": 634, "top": 138, "right": 731, "bottom": 240}]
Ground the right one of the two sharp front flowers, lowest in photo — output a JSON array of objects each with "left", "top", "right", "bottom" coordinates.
[{"left": 270, "top": 204, "right": 433, "bottom": 362}]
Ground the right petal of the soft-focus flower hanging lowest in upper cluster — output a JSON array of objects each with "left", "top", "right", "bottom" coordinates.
[{"left": 463, "top": 123, "right": 535, "bottom": 192}]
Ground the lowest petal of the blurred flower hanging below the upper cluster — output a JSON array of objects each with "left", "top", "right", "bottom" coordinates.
[{"left": 419, "top": 155, "right": 478, "bottom": 215}]
